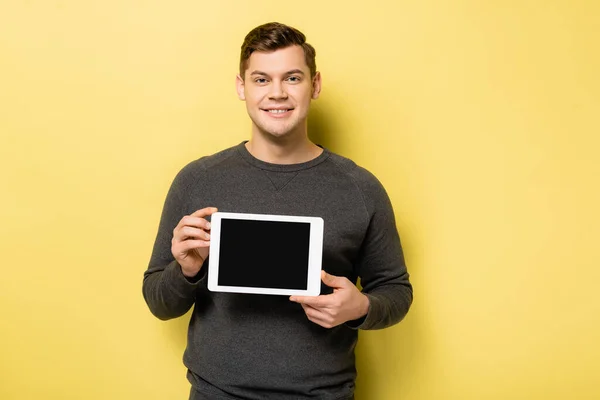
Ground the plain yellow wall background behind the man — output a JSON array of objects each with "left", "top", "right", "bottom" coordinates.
[{"left": 0, "top": 0, "right": 600, "bottom": 400}]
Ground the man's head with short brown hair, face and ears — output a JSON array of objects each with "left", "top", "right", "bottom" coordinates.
[{"left": 237, "top": 22, "right": 321, "bottom": 138}]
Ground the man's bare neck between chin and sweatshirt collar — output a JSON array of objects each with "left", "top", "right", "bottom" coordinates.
[{"left": 246, "top": 134, "right": 323, "bottom": 164}]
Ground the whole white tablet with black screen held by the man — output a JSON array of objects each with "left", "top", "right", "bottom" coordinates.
[{"left": 208, "top": 212, "right": 323, "bottom": 296}]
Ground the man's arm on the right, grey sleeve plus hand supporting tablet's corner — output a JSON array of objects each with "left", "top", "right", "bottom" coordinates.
[{"left": 290, "top": 170, "right": 413, "bottom": 329}]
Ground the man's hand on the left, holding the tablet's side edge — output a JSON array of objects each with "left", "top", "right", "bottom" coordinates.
[{"left": 171, "top": 207, "right": 217, "bottom": 278}]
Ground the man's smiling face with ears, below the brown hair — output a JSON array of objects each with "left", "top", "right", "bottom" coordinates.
[{"left": 237, "top": 46, "right": 321, "bottom": 139}]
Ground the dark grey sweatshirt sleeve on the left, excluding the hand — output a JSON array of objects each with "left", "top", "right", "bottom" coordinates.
[{"left": 142, "top": 166, "right": 206, "bottom": 320}]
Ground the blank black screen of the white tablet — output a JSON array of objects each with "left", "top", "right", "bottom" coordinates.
[{"left": 218, "top": 218, "right": 310, "bottom": 290}]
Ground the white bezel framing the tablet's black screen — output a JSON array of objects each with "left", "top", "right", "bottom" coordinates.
[{"left": 208, "top": 212, "right": 324, "bottom": 296}]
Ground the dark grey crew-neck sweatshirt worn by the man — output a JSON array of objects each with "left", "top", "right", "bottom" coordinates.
[{"left": 143, "top": 143, "right": 412, "bottom": 400}]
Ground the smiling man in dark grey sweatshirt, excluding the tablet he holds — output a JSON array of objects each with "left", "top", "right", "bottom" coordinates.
[{"left": 143, "top": 23, "right": 412, "bottom": 400}]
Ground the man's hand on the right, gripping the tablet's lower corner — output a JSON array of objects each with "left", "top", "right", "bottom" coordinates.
[{"left": 290, "top": 271, "right": 369, "bottom": 328}]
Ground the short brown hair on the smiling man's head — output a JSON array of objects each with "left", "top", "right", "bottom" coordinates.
[{"left": 240, "top": 22, "right": 317, "bottom": 79}]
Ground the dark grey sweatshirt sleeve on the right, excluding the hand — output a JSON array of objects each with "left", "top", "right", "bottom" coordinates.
[{"left": 348, "top": 170, "right": 413, "bottom": 329}]
